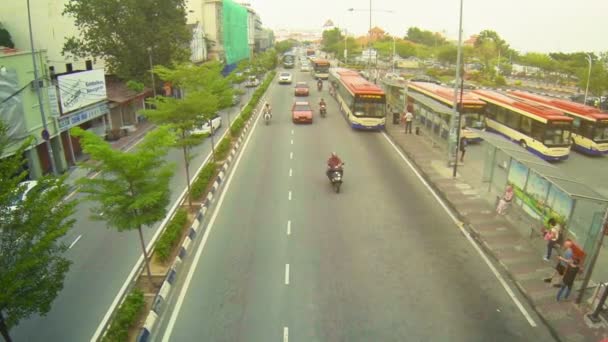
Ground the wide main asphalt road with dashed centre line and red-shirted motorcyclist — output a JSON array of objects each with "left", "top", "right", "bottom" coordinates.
[{"left": 156, "top": 71, "right": 553, "bottom": 341}]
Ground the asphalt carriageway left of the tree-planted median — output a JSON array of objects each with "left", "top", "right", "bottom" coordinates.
[{"left": 11, "top": 90, "right": 253, "bottom": 342}]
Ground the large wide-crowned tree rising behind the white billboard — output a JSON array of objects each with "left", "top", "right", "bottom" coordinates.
[{"left": 63, "top": 0, "right": 191, "bottom": 82}]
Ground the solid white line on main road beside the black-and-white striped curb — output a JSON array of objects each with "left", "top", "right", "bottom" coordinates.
[{"left": 162, "top": 108, "right": 261, "bottom": 342}]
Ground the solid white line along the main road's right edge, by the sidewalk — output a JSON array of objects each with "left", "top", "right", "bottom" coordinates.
[{"left": 382, "top": 132, "right": 536, "bottom": 327}]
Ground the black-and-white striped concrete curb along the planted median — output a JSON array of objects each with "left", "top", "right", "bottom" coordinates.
[{"left": 136, "top": 87, "right": 262, "bottom": 342}]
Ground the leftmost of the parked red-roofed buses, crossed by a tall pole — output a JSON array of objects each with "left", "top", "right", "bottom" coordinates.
[{"left": 407, "top": 82, "right": 486, "bottom": 142}]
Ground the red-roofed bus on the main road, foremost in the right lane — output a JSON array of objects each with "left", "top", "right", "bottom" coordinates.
[{"left": 329, "top": 68, "right": 386, "bottom": 130}]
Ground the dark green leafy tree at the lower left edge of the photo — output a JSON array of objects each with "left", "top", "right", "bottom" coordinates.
[{"left": 0, "top": 120, "right": 75, "bottom": 341}]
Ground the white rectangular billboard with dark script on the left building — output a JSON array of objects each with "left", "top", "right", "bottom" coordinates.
[{"left": 57, "top": 70, "right": 107, "bottom": 114}]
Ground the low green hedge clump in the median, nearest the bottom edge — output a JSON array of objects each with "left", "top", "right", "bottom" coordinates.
[{"left": 103, "top": 289, "right": 145, "bottom": 342}]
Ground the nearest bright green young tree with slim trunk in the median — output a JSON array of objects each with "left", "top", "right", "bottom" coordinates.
[{"left": 71, "top": 126, "right": 174, "bottom": 284}]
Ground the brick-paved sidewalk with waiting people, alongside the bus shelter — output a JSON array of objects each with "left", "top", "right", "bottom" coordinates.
[{"left": 386, "top": 122, "right": 608, "bottom": 342}]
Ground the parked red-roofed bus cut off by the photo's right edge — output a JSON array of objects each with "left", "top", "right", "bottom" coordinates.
[{"left": 508, "top": 90, "right": 608, "bottom": 156}]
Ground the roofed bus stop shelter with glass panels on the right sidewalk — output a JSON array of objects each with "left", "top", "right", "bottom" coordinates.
[{"left": 479, "top": 132, "right": 608, "bottom": 276}]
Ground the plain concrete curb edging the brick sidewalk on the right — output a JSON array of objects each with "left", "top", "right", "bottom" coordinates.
[{"left": 385, "top": 130, "right": 562, "bottom": 342}]
